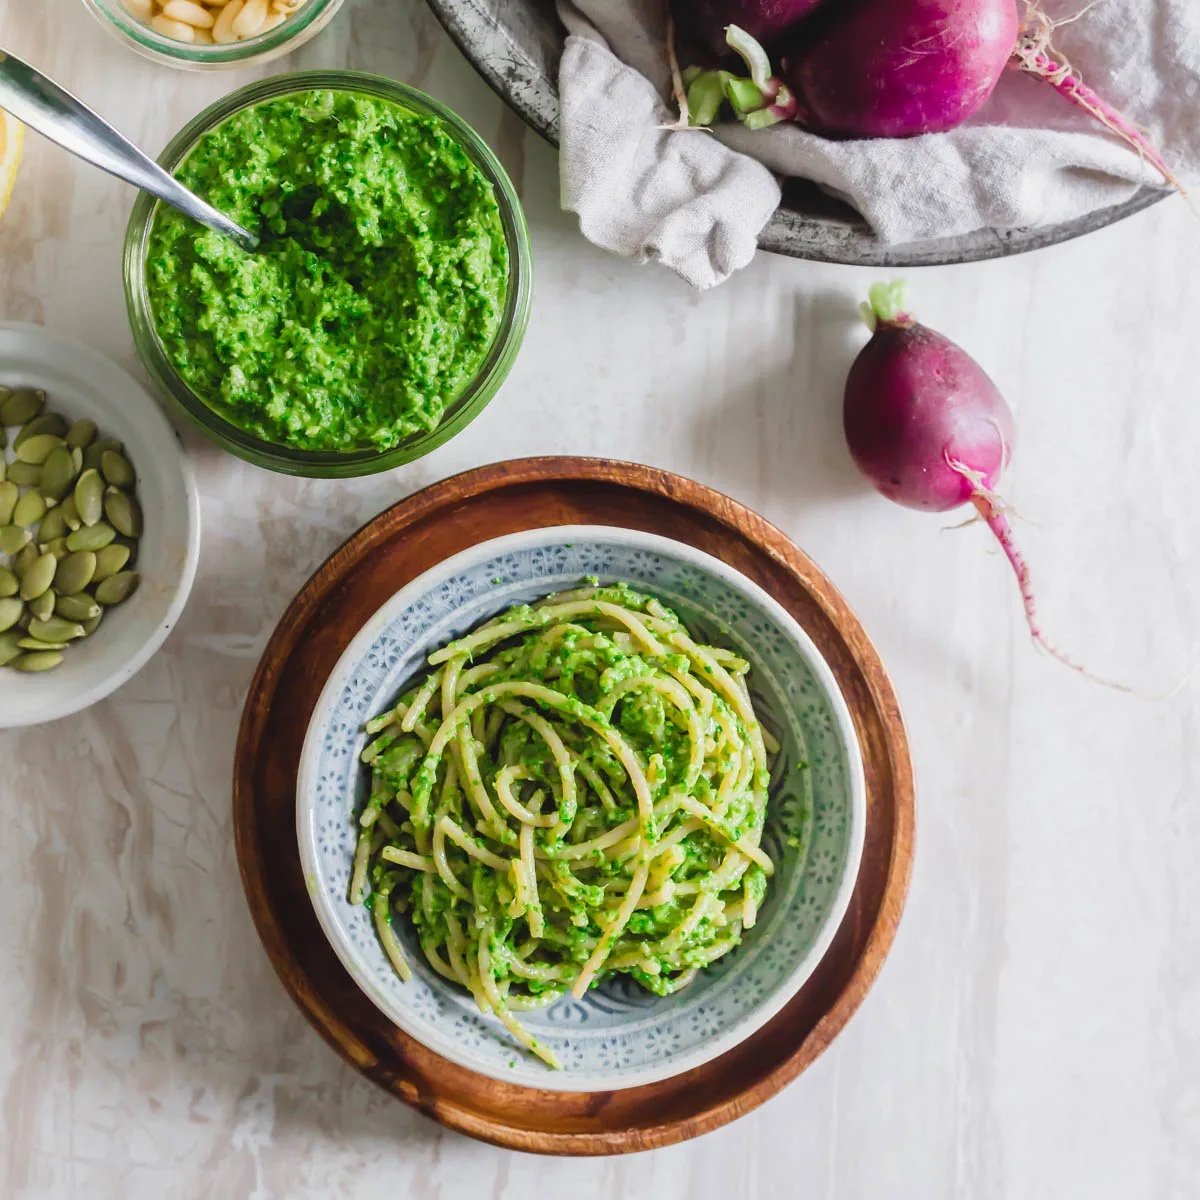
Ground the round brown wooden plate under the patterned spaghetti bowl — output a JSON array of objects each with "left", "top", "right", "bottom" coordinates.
[{"left": 233, "top": 458, "right": 913, "bottom": 1154}]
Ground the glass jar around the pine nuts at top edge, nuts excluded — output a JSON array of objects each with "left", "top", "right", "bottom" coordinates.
[{"left": 83, "top": 0, "right": 343, "bottom": 71}]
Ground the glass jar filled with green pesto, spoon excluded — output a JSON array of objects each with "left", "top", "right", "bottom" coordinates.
[{"left": 124, "top": 71, "right": 532, "bottom": 476}]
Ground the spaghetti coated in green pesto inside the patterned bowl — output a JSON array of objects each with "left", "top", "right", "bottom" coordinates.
[{"left": 350, "top": 584, "right": 776, "bottom": 1067}]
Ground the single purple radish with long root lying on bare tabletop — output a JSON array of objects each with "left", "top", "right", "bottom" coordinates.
[{"left": 842, "top": 282, "right": 1099, "bottom": 676}]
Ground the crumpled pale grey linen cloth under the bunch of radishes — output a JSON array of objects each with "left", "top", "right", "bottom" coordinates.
[{"left": 558, "top": 0, "right": 1200, "bottom": 288}]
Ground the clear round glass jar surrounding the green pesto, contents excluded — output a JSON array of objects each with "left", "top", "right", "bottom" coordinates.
[{"left": 124, "top": 71, "right": 533, "bottom": 478}]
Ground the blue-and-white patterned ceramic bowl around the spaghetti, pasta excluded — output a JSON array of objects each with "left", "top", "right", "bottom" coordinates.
[{"left": 296, "top": 526, "right": 866, "bottom": 1091}]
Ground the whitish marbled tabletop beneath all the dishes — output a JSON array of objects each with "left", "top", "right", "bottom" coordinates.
[{"left": 0, "top": 0, "right": 1200, "bottom": 1200}]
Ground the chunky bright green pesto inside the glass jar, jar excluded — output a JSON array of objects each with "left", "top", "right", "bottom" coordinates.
[{"left": 146, "top": 91, "right": 509, "bottom": 451}]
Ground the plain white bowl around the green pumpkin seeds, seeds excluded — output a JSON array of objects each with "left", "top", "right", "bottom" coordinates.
[{"left": 0, "top": 323, "right": 200, "bottom": 728}]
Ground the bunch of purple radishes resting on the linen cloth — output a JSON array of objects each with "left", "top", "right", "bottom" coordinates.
[{"left": 671, "top": 0, "right": 1177, "bottom": 186}]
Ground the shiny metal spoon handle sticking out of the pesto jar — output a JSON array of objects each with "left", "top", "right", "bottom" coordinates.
[{"left": 0, "top": 50, "right": 258, "bottom": 251}]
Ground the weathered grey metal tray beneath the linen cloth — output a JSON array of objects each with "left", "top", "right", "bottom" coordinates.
[{"left": 428, "top": 0, "right": 1166, "bottom": 266}]
